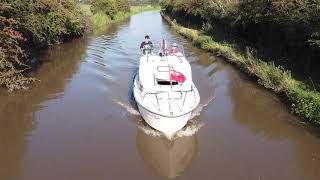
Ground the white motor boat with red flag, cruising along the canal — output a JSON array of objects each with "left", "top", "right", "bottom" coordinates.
[{"left": 133, "top": 42, "right": 200, "bottom": 136}]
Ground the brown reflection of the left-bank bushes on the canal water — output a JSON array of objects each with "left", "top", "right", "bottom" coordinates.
[{"left": 0, "top": 38, "right": 87, "bottom": 180}]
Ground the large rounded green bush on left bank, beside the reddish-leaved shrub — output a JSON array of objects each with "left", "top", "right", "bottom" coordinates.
[{"left": 4, "top": 0, "right": 85, "bottom": 47}]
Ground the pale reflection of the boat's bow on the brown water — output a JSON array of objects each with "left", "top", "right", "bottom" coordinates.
[{"left": 137, "top": 130, "right": 198, "bottom": 179}]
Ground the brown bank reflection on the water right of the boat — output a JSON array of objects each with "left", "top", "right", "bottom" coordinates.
[{"left": 229, "top": 73, "right": 320, "bottom": 179}]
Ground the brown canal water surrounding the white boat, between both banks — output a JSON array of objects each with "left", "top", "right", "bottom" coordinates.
[{"left": 0, "top": 11, "right": 320, "bottom": 180}]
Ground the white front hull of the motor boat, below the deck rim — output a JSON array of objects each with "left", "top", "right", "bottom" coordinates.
[{"left": 138, "top": 104, "right": 191, "bottom": 136}]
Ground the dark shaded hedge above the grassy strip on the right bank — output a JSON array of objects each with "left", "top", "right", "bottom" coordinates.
[{"left": 161, "top": 0, "right": 320, "bottom": 79}]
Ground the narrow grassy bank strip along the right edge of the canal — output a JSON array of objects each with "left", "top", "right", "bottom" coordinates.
[{"left": 160, "top": 11, "right": 320, "bottom": 127}]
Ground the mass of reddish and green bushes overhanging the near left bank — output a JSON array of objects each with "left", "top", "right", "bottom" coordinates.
[{"left": 0, "top": 0, "right": 85, "bottom": 90}]
